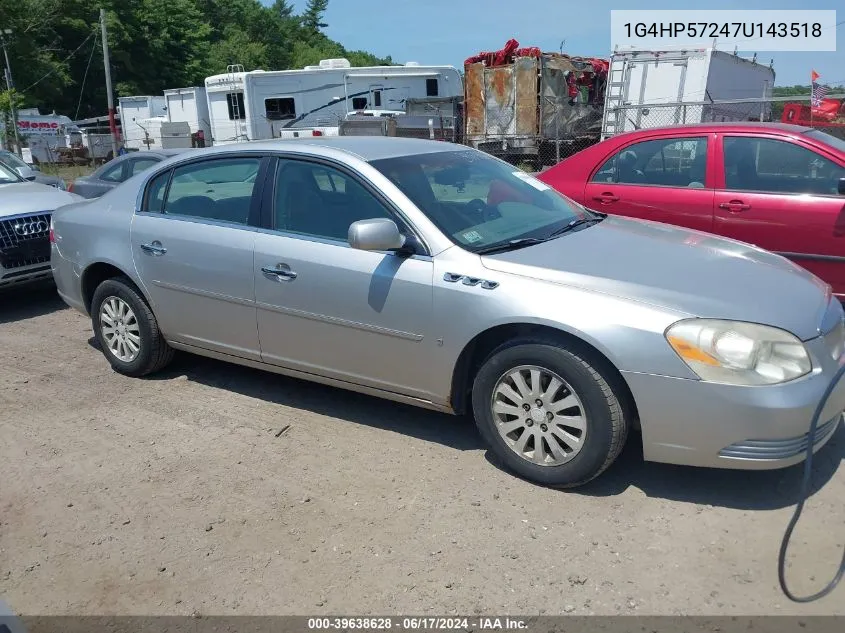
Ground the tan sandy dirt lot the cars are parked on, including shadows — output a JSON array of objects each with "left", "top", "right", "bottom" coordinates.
[{"left": 0, "top": 280, "right": 845, "bottom": 615}]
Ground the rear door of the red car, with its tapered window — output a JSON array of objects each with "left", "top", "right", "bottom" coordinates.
[{"left": 584, "top": 133, "right": 715, "bottom": 231}]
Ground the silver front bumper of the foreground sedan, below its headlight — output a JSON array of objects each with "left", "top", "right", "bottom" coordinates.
[{"left": 623, "top": 326, "right": 845, "bottom": 470}]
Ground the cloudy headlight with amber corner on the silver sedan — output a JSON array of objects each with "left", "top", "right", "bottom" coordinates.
[{"left": 666, "top": 319, "right": 813, "bottom": 385}]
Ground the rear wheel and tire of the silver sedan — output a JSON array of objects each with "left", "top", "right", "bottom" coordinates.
[{"left": 91, "top": 277, "right": 174, "bottom": 378}]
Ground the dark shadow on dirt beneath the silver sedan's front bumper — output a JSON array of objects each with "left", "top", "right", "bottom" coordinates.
[{"left": 572, "top": 420, "right": 845, "bottom": 510}]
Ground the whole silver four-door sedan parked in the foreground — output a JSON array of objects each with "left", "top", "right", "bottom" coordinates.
[{"left": 52, "top": 137, "right": 845, "bottom": 487}]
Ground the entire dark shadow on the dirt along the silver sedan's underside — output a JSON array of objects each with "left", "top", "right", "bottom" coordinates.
[{"left": 88, "top": 344, "right": 845, "bottom": 510}]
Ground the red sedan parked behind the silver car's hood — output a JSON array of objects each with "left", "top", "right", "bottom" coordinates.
[{"left": 538, "top": 123, "right": 845, "bottom": 301}]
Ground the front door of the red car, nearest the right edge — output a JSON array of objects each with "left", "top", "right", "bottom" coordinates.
[{"left": 713, "top": 132, "right": 845, "bottom": 297}]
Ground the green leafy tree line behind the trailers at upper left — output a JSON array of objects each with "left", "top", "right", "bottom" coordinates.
[{"left": 0, "top": 0, "right": 393, "bottom": 118}]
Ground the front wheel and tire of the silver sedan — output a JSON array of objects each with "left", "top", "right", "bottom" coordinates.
[{"left": 472, "top": 340, "right": 629, "bottom": 488}]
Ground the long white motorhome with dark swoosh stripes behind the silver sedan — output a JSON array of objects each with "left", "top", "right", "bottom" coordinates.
[{"left": 205, "top": 59, "right": 463, "bottom": 145}]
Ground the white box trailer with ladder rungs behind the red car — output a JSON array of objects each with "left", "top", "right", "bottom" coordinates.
[{"left": 601, "top": 47, "right": 775, "bottom": 140}]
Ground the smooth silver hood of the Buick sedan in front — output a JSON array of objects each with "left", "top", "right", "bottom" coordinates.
[{"left": 482, "top": 216, "right": 830, "bottom": 340}]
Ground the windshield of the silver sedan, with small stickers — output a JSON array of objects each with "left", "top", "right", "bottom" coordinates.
[{"left": 371, "top": 150, "right": 592, "bottom": 252}]
